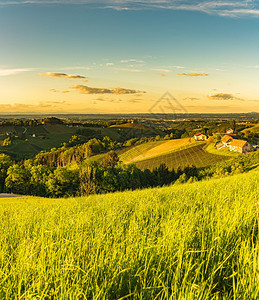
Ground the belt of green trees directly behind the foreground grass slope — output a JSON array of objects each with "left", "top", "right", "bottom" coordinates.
[{"left": 0, "top": 151, "right": 197, "bottom": 197}]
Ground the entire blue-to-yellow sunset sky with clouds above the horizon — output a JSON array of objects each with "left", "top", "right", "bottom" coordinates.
[{"left": 0, "top": 0, "right": 259, "bottom": 114}]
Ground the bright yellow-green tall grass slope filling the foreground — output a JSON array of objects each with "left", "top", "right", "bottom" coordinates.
[{"left": 0, "top": 169, "right": 259, "bottom": 299}]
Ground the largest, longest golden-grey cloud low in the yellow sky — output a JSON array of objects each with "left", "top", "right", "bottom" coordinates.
[{"left": 70, "top": 84, "right": 145, "bottom": 95}]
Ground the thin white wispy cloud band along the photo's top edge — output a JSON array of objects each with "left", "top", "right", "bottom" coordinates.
[{"left": 0, "top": 0, "right": 259, "bottom": 17}]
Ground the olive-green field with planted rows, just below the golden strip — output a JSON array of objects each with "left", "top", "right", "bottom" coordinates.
[{"left": 135, "top": 143, "right": 229, "bottom": 170}]
